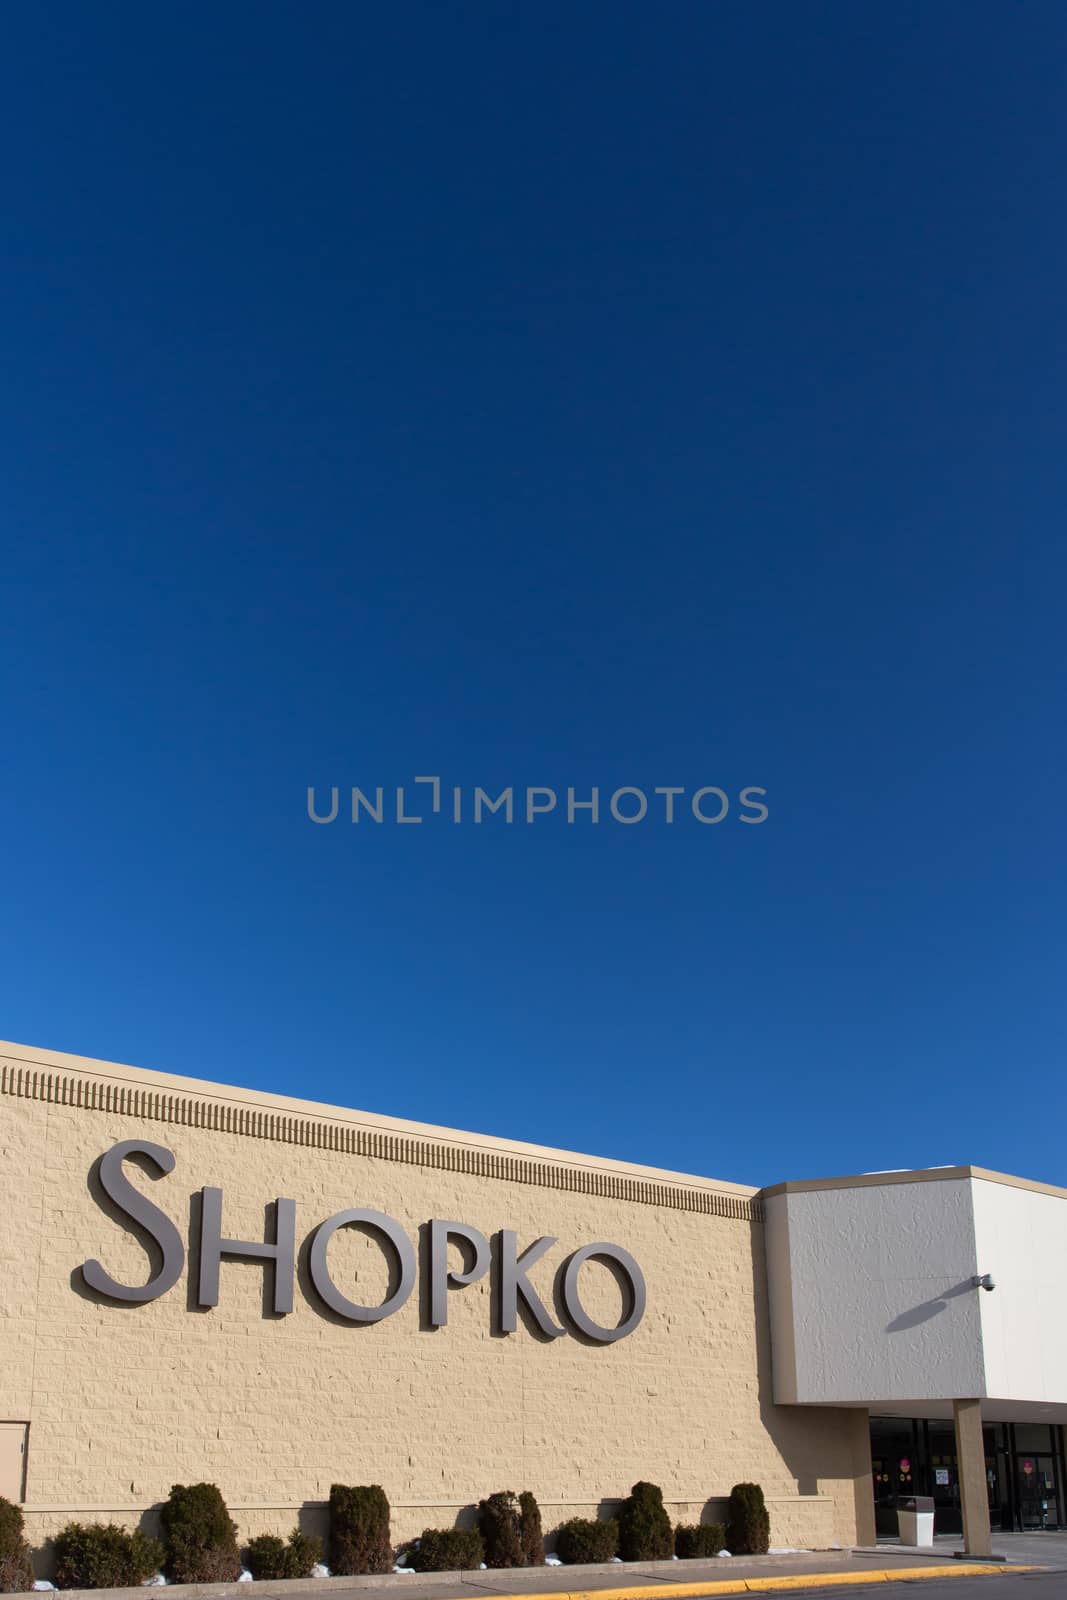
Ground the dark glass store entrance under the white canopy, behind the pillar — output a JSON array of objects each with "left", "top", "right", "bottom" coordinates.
[{"left": 870, "top": 1416, "right": 1067, "bottom": 1539}]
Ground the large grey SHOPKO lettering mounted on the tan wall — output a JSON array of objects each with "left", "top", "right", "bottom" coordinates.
[{"left": 82, "top": 1139, "right": 645, "bottom": 1344}]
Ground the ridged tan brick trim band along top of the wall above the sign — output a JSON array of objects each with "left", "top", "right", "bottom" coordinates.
[{"left": 0, "top": 1064, "right": 763, "bottom": 1222}]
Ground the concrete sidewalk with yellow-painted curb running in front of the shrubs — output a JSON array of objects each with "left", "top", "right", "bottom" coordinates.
[{"left": 22, "top": 1549, "right": 1035, "bottom": 1600}]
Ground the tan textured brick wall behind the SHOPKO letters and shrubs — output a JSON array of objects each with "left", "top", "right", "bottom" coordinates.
[{"left": 0, "top": 1058, "right": 854, "bottom": 1568}]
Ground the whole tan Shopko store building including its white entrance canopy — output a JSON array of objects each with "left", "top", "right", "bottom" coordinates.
[{"left": 0, "top": 1045, "right": 1067, "bottom": 1550}]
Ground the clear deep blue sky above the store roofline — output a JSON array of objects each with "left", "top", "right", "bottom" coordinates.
[{"left": 0, "top": 0, "right": 1067, "bottom": 1182}]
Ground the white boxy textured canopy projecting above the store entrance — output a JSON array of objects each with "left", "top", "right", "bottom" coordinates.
[{"left": 765, "top": 1166, "right": 1067, "bottom": 1424}]
